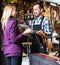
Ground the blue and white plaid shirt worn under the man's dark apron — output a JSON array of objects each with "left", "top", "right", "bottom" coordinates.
[{"left": 30, "top": 16, "right": 52, "bottom": 35}]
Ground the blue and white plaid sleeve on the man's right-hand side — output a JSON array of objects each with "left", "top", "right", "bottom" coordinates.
[{"left": 42, "top": 19, "right": 52, "bottom": 35}]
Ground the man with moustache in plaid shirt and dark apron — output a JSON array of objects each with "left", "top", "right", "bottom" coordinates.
[{"left": 31, "top": 2, "right": 52, "bottom": 53}]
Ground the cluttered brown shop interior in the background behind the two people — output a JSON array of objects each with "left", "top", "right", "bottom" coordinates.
[{"left": 0, "top": 0, "right": 60, "bottom": 63}]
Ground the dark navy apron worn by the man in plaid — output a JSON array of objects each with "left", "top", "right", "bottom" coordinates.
[{"left": 31, "top": 17, "right": 47, "bottom": 54}]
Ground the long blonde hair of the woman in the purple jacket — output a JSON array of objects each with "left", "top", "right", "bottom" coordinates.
[{"left": 1, "top": 4, "right": 16, "bottom": 29}]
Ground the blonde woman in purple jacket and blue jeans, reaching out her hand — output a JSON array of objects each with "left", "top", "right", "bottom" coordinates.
[{"left": 1, "top": 4, "right": 32, "bottom": 65}]
